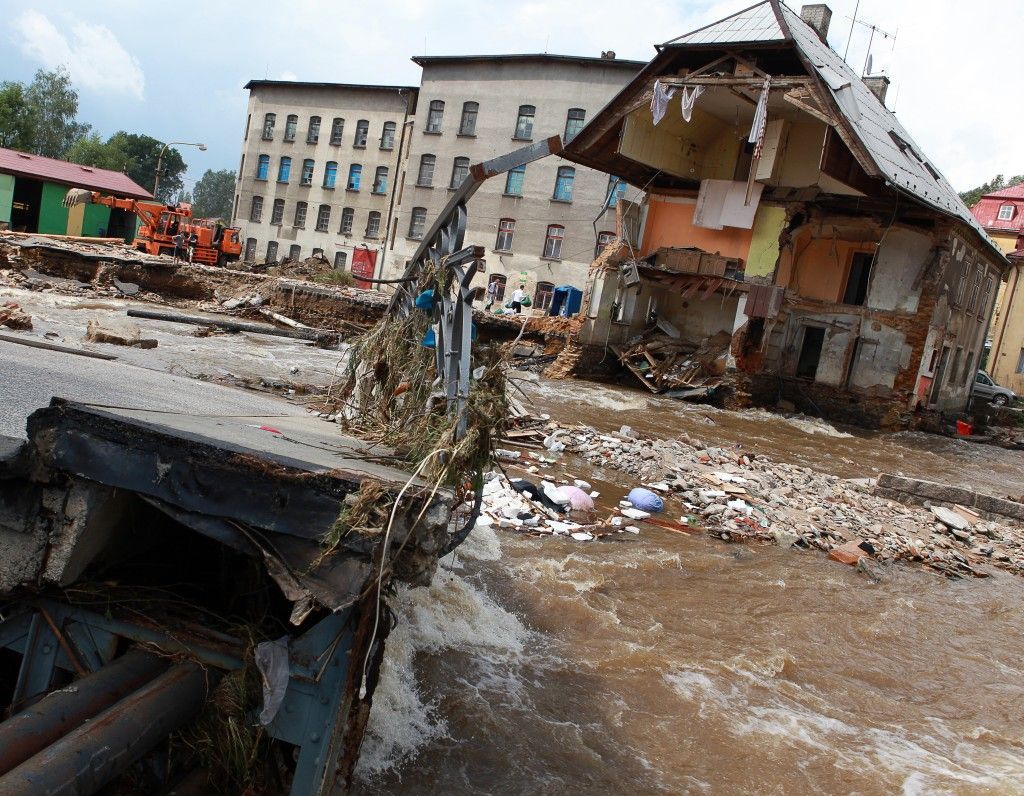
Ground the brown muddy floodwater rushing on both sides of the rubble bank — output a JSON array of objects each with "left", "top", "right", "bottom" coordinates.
[{"left": 358, "top": 382, "right": 1024, "bottom": 794}]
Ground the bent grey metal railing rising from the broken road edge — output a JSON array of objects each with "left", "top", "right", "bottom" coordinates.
[{"left": 388, "top": 135, "right": 562, "bottom": 439}]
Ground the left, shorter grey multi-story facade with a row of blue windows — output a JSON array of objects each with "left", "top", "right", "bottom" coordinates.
[{"left": 232, "top": 80, "right": 417, "bottom": 268}]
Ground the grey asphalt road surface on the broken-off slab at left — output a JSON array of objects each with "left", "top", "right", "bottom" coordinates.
[{"left": 0, "top": 333, "right": 304, "bottom": 437}]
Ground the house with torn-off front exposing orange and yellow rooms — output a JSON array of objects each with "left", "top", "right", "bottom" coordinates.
[{"left": 563, "top": 0, "right": 1008, "bottom": 426}]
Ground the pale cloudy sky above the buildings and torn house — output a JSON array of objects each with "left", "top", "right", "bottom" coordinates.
[{"left": 0, "top": 0, "right": 1024, "bottom": 190}]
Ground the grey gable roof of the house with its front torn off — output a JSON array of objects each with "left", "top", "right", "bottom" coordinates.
[{"left": 647, "top": 0, "right": 1001, "bottom": 256}]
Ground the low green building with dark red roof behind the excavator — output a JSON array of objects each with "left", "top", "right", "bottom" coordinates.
[{"left": 0, "top": 148, "right": 153, "bottom": 240}]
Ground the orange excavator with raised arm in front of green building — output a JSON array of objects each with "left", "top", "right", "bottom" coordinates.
[{"left": 63, "top": 187, "right": 242, "bottom": 265}]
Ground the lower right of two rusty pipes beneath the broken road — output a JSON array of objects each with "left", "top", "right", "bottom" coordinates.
[{"left": 0, "top": 663, "right": 219, "bottom": 796}]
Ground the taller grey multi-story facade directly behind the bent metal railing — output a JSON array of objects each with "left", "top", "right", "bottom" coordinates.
[{"left": 386, "top": 53, "right": 643, "bottom": 308}]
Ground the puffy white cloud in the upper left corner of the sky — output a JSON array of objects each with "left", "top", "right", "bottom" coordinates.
[{"left": 12, "top": 10, "right": 145, "bottom": 99}]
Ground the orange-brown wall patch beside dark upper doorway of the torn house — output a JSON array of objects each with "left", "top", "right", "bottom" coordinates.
[{"left": 777, "top": 232, "right": 874, "bottom": 301}]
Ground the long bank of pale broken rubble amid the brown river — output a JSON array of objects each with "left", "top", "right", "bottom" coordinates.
[{"left": 528, "top": 415, "right": 1024, "bottom": 577}]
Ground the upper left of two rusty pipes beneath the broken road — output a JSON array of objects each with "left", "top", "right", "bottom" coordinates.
[{"left": 0, "top": 650, "right": 167, "bottom": 774}]
